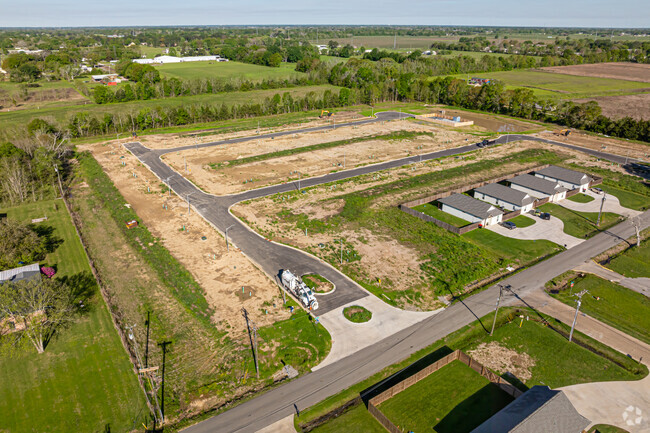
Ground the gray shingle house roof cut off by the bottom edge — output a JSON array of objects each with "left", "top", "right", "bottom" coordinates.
[{"left": 472, "top": 385, "right": 590, "bottom": 433}]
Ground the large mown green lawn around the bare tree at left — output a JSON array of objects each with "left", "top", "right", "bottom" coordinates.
[{"left": 0, "top": 200, "right": 148, "bottom": 432}]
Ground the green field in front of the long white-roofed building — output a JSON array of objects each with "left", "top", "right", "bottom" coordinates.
[{"left": 154, "top": 62, "right": 305, "bottom": 81}]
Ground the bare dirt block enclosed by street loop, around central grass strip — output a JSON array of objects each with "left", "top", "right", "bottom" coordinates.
[{"left": 163, "top": 121, "right": 476, "bottom": 194}]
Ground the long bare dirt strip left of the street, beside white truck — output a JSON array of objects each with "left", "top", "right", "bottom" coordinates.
[{"left": 78, "top": 140, "right": 289, "bottom": 333}]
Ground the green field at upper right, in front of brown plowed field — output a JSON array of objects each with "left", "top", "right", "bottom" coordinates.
[{"left": 448, "top": 69, "right": 650, "bottom": 99}]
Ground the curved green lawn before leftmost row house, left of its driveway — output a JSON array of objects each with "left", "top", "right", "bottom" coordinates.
[{"left": 462, "top": 230, "right": 564, "bottom": 264}]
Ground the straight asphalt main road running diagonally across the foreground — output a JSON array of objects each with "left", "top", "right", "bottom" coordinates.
[{"left": 184, "top": 211, "right": 650, "bottom": 433}]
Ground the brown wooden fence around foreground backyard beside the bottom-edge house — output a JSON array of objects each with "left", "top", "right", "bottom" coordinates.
[{"left": 368, "top": 350, "right": 523, "bottom": 433}]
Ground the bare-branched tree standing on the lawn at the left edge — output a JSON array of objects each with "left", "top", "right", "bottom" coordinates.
[{"left": 0, "top": 278, "right": 82, "bottom": 353}]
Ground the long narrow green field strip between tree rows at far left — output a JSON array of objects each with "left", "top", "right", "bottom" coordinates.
[{"left": 0, "top": 85, "right": 339, "bottom": 132}]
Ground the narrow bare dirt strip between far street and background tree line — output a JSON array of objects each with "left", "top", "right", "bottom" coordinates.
[{"left": 135, "top": 111, "right": 364, "bottom": 149}]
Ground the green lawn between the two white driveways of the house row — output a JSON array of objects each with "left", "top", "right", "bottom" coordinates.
[{"left": 537, "top": 203, "right": 622, "bottom": 239}]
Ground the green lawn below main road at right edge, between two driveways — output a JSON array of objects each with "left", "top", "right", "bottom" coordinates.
[{"left": 553, "top": 274, "right": 650, "bottom": 344}]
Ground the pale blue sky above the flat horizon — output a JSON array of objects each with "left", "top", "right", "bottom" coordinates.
[{"left": 0, "top": 0, "right": 650, "bottom": 28}]
